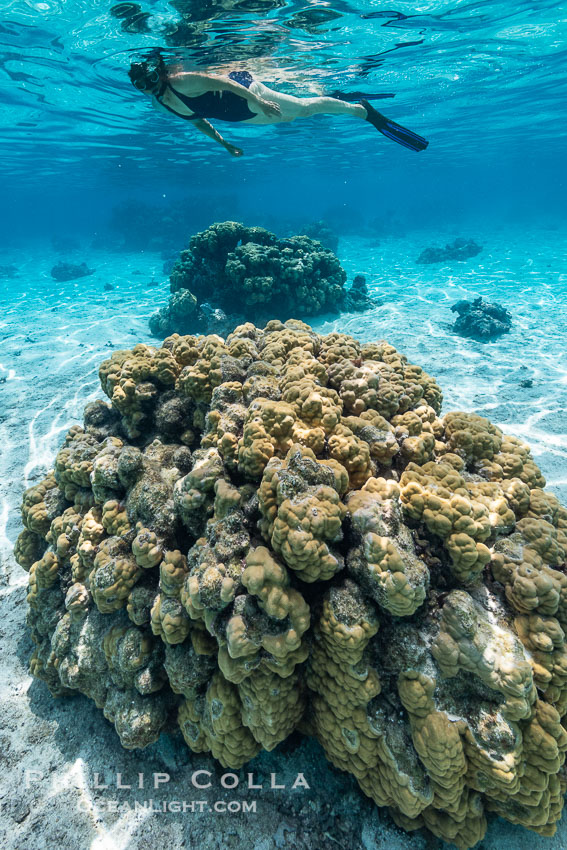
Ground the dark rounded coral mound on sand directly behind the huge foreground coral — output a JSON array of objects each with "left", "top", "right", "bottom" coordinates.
[{"left": 150, "top": 221, "right": 373, "bottom": 336}]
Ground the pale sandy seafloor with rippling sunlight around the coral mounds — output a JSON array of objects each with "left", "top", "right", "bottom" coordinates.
[{"left": 0, "top": 227, "right": 567, "bottom": 850}]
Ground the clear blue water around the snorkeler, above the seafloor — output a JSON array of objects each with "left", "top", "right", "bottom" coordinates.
[{"left": 0, "top": 0, "right": 567, "bottom": 239}]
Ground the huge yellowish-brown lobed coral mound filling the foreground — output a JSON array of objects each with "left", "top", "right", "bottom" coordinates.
[{"left": 16, "top": 320, "right": 567, "bottom": 848}]
